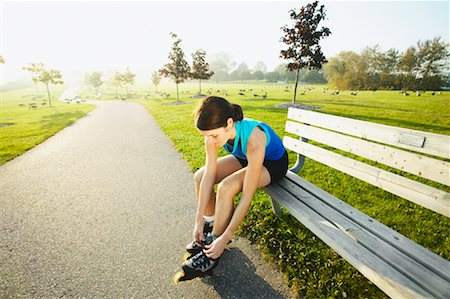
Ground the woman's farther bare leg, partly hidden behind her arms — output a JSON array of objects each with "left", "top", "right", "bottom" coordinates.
[{"left": 194, "top": 155, "right": 242, "bottom": 216}]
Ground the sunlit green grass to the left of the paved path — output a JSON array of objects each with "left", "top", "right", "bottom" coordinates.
[{"left": 0, "top": 86, "right": 95, "bottom": 165}]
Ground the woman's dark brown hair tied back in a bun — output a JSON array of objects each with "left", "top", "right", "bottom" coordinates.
[{"left": 195, "top": 96, "right": 244, "bottom": 131}]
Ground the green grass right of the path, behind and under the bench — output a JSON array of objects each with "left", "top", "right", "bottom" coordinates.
[{"left": 134, "top": 83, "right": 450, "bottom": 298}]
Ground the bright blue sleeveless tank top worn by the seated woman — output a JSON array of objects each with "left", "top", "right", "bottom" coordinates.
[{"left": 223, "top": 118, "right": 285, "bottom": 160}]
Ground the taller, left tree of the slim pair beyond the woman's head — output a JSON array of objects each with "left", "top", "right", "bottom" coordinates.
[{"left": 159, "top": 32, "right": 190, "bottom": 101}]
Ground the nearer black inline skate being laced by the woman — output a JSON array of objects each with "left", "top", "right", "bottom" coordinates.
[{"left": 174, "top": 233, "right": 220, "bottom": 283}]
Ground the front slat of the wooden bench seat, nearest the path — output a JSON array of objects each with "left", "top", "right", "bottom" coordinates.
[{"left": 265, "top": 183, "right": 433, "bottom": 298}]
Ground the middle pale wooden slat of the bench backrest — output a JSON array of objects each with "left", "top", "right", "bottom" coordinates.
[{"left": 286, "top": 121, "right": 450, "bottom": 185}]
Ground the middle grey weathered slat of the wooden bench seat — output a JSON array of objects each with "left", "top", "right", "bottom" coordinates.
[{"left": 278, "top": 173, "right": 450, "bottom": 297}]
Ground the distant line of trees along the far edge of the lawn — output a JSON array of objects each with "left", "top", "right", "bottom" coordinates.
[{"left": 210, "top": 38, "right": 450, "bottom": 90}]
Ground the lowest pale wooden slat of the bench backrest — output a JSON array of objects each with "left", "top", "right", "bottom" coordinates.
[{"left": 283, "top": 136, "right": 450, "bottom": 217}]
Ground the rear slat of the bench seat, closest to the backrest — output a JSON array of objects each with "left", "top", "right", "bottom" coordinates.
[{"left": 285, "top": 171, "right": 450, "bottom": 287}]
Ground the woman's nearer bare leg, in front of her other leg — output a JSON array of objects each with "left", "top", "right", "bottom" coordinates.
[{"left": 213, "top": 167, "right": 271, "bottom": 237}]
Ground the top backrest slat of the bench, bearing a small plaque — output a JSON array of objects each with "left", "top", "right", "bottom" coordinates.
[{"left": 288, "top": 108, "right": 450, "bottom": 159}]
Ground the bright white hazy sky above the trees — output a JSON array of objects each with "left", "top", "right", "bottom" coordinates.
[{"left": 0, "top": 1, "right": 449, "bottom": 83}]
